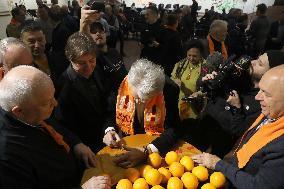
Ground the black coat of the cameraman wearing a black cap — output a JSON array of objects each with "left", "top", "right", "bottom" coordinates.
[{"left": 188, "top": 88, "right": 261, "bottom": 157}]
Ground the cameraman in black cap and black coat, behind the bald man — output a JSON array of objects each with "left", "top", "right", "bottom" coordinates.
[{"left": 194, "top": 51, "right": 284, "bottom": 156}]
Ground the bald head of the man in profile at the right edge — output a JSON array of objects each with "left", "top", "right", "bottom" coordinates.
[{"left": 255, "top": 65, "right": 284, "bottom": 119}]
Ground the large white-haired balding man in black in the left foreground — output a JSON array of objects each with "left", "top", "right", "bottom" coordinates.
[{"left": 0, "top": 66, "right": 110, "bottom": 189}]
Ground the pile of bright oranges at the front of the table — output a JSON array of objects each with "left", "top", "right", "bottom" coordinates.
[{"left": 116, "top": 151, "right": 226, "bottom": 189}]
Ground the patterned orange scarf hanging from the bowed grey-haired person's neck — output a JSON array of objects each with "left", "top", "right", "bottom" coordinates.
[{"left": 116, "top": 77, "right": 166, "bottom": 135}]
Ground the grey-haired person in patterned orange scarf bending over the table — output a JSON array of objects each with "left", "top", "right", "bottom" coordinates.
[{"left": 104, "top": 59, "right": 180, "bottom": 166}]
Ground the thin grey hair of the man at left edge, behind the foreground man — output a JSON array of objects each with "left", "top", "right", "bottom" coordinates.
[{"left": 0, "top": 37, "right": 30, "bottom": 70}]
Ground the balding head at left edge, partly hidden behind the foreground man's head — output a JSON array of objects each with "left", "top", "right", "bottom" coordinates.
[{"left": 0, "top": 38, "right": 33, "bottom": 74}]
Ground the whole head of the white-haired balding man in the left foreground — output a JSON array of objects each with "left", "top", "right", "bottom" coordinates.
[{"left": 0, "top": 66, "right": 57, "bottom": 125}]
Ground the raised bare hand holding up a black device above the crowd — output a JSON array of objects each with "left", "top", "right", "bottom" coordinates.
[{"left": 80, "top": 5, "right": 100, "bottom": 33}]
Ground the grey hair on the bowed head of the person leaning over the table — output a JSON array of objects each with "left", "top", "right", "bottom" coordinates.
[{"left": 128, "top": 59, "right": 165, "bottom": 100}]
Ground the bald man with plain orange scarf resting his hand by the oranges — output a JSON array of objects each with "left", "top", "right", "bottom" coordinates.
[{"left": 192, "top": 65, "right": 284, "bottom": 189}]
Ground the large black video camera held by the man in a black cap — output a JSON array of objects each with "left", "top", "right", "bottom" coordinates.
[{"left": 202, "top": 55, "right": 251, "bottom": 93}]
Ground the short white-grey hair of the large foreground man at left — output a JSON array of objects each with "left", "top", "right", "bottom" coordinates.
[{"left": 0, "top": 65, "right": 52, "bottom": 111}]
